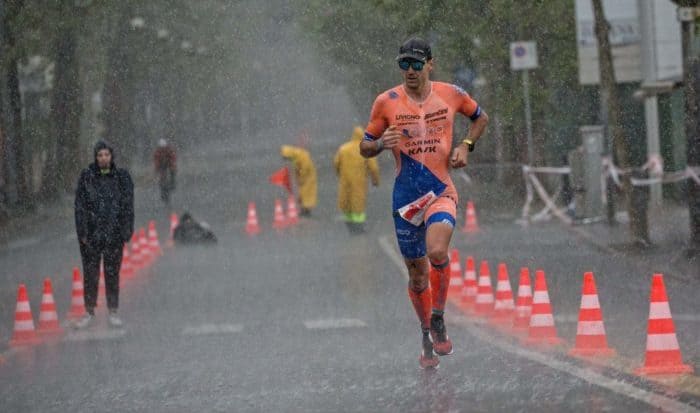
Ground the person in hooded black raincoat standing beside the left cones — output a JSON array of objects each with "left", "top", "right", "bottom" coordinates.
[{"left": 74, "top": 141, "right": 134, "bottom": 328}]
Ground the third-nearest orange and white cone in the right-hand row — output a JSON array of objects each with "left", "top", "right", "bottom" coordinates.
[{"left": 525, "top": 270, "right": 561, "bottom": 345}]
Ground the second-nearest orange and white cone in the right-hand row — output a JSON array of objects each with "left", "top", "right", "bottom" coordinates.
[{"left": 569, "top": 272, "right": 615, "bottom": 356}]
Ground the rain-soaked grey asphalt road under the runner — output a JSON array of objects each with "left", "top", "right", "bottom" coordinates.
[{"left": 0, "top": 138, "right": 700, "bottom": 413}]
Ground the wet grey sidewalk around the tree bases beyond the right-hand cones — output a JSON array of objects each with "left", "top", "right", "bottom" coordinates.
[{"left": 568, "top": 201, "right": 700, "bottom": 281}]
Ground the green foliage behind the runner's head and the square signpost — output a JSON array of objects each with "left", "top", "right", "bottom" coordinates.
[{"left": 299, "top": 0, "right": 588, "bottom": 161}]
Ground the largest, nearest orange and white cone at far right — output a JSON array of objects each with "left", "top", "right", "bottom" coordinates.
[{"left": 634, "top": 274, "right": 693, "bottom": 375}]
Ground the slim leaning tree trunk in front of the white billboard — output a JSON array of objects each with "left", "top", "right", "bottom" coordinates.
[{"left": 593, "top": 0, "right": 650, "bottom": 245}]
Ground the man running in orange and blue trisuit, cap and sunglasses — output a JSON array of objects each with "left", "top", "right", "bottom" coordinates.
[{"left": 360, "top": 37, "right": 488, "bottom": 368}]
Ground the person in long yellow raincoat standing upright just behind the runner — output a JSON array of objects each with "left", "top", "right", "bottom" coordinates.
[{"left": 333, "top": 126, "right": 379, "bottom": 233}]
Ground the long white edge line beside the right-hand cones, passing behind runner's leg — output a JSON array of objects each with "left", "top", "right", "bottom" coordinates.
[{"left": 379, "top": 236, "right": 700, "bottom": 413}]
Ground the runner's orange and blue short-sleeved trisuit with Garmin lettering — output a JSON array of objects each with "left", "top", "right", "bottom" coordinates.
[{"left": 364, "top": 82, "right": 481, "bottom": 259}]
